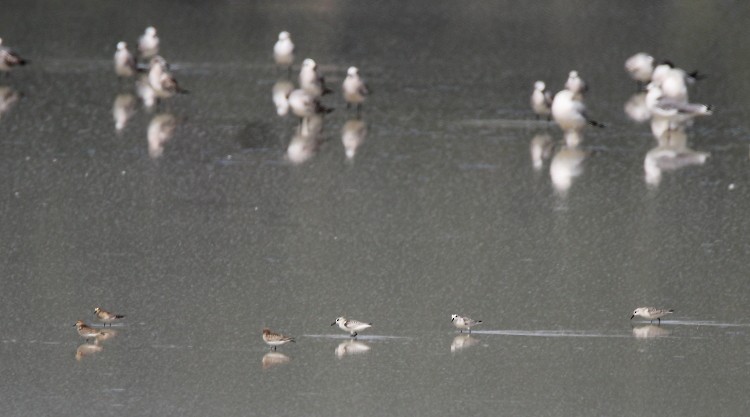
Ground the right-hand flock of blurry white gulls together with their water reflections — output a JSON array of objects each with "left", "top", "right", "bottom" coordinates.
[{"left": 530, "top": 52, "right": 712, "bottom": 188}]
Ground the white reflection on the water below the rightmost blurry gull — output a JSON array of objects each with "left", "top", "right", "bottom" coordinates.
[{"left": 643, "top": 130, "right": 709, "bottom": 186}]
